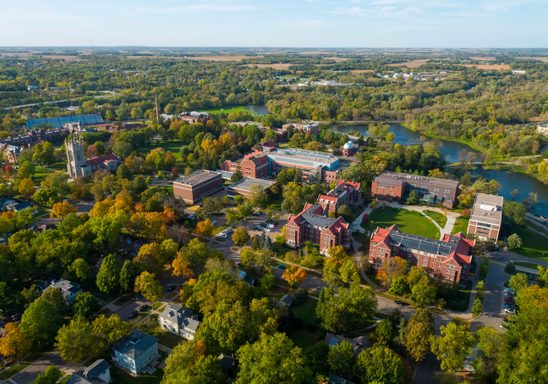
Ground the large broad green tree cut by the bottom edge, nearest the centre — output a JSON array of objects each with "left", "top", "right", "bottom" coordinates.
[{"left": 235, "top": 333, "right": 312, "bottom": 384}]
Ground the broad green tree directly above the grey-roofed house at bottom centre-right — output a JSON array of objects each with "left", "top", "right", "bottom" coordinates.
[{"left": 316, "top": 284, "right": 377, "bottom": 333}]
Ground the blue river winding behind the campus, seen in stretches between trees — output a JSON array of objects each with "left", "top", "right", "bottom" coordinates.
[{"left": 333, "top": 124, "right": 548, "bottom": 217}]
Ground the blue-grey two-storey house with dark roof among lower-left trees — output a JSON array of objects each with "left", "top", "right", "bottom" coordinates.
[{"left": 112, "top": 330, "right": 160, "bottom": 375}]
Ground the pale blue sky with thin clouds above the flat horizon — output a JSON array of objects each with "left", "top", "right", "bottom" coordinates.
[{"left": 0, "top": 0, "right": 548, "bottom": 48}]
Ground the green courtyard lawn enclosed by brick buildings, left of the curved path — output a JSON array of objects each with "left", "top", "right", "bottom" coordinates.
[{"left": 367, "top": 207, "right": 440, "bottom": 240}]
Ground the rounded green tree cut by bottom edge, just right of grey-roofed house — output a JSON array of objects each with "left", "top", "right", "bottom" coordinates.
[{"left": 356, "top": 345, "right": 404, "bottom": 384}]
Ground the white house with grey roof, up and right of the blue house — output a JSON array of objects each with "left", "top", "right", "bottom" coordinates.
[{"left": 158, "top": 303, "right": 200, "bottom": 340}]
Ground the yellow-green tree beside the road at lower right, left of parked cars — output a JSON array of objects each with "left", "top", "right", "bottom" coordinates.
[{"left": 430, "top": 322, "right": 474, "bottom": 372}]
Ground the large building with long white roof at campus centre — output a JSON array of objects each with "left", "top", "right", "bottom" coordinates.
[{"left": 266, "top": 148, "right": 341, "bottom": 183}]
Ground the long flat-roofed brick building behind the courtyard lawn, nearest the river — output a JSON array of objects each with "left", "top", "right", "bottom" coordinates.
[{"left": 371, "top": 172, "right": 459, "bottom": 208}]
